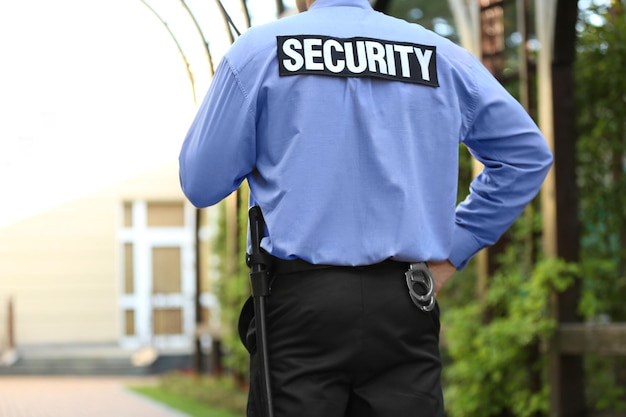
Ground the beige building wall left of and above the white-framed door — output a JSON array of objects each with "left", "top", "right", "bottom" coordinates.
[{"left": 0, "top": 164, "right": 183, "bottom": 351}]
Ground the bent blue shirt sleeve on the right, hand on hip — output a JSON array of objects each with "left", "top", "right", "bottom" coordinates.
[{"left": 450, "top": 57, "right": 552, "bottom": 269}]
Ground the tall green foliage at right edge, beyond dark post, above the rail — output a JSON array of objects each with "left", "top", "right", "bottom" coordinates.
[{"left": 576, "top": 2, "right": 626, "bottom": 321}]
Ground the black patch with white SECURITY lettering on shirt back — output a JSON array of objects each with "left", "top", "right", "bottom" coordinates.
[{"left": 276, "top": 35, "right": 439, "bottom": 87}]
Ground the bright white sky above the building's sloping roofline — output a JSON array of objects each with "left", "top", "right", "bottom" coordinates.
[{"left": 0, "top": 0, "right": 288, "bottom": 227}]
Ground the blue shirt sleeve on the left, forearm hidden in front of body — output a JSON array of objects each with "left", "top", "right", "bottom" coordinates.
[{"left": 179, "top": 58, "right": 256, "bottom": 207}]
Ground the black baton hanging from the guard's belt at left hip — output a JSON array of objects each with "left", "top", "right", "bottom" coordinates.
[{"left": 248, "top": 206, "right": 274, "bottom": 417}]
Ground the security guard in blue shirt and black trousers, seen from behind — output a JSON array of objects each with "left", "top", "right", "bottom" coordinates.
[{"left": 180, "top": 0, "right": 552, "bottom": 417}]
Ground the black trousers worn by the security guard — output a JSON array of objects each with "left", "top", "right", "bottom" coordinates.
[{"left": 241, "top": 262, "right": 444, "bottom": 417}]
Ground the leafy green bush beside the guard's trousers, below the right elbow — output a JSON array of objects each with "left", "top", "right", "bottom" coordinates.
[{"left": 442, "top": 259, "right": 578, "bottom": 417}]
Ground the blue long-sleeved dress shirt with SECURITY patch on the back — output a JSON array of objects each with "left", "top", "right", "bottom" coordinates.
[{"left": 180, "top": 0, "right": 552, "bottom": 268}]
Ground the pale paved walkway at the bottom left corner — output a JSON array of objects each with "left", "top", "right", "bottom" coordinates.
[{"left": 0, "top": 376, "right": 187, "bottom": 417}]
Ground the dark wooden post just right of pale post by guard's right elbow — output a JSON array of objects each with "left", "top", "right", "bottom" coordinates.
[{"left": 552, "top": 0, "right": 586, "bottom": 417}]
